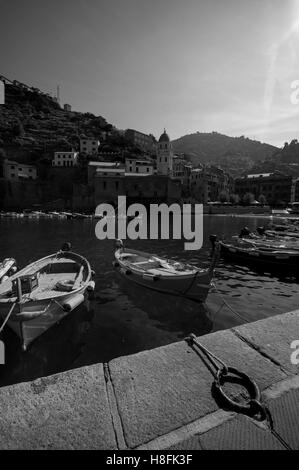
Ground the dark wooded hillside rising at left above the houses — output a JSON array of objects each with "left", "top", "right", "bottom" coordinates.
[{"left": 0, "top": 84, "right": 117, "bottom": 162}]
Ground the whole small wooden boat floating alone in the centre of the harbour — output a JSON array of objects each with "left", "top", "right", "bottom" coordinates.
[{"left": 114, "top": 240, "right": 216, "bottom": 302}]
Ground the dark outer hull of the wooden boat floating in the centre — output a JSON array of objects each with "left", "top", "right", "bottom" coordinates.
[{"left": 114, "top": 246, "right": 213, "bottom": 302}]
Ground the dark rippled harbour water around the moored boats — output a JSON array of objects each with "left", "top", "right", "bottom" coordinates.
[{"left": 0, "top": 216, "right": 299, "bottom": 385}]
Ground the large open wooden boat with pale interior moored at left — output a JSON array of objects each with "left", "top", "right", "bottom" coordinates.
[{"left": 0, "top": 246, "right": 94, "bottom": 349}]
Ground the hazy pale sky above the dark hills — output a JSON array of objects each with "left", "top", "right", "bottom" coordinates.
[{"left": 0, "top": 0, "right": 299, "bottom": 146}]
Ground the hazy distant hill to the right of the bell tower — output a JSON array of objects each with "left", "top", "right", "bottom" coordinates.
[{"left": 172, "top": 132, "right": 277, "bottom": 170}]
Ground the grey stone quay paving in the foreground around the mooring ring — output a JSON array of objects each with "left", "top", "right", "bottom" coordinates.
[{"left": 0, "top": 310, "right": 299, "bottom": 450}]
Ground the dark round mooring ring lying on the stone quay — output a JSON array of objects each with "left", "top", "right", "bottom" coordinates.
[{"left": 214, "top": 367, "right": 261, "bottom": 414}]
